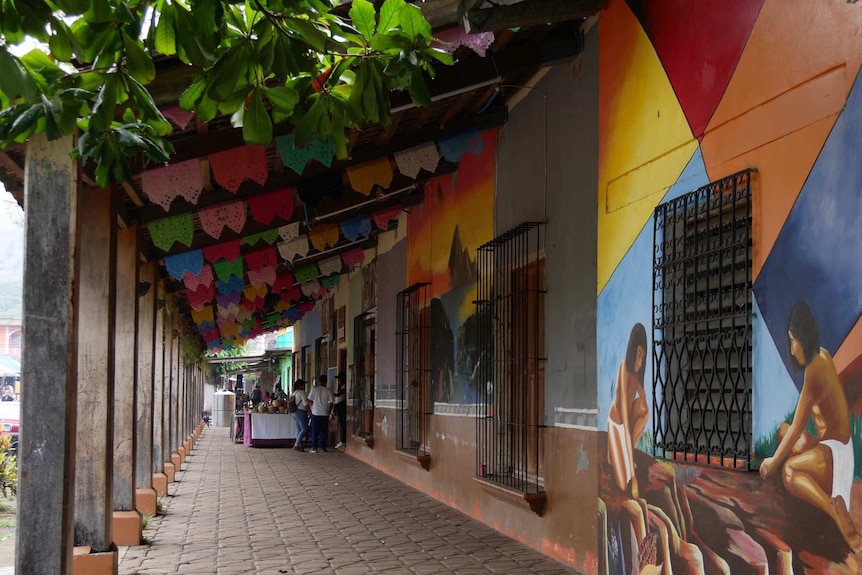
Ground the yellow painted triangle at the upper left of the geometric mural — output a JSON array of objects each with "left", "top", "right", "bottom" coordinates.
[{"left": 597, "top": 0, "right": 697, "bottom": 293}]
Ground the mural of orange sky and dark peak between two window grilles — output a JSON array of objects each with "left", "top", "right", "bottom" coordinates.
[{"left": 407, "top": 131, "right": 497, "bottom": 404}]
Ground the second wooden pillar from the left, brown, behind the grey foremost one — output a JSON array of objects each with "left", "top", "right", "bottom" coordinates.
[{"left": 74, "top": 186, "right": 116, "bottom": 573}]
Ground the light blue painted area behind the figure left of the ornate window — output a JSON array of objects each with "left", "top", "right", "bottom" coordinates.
[{"left": 596, "top": 148, "right": 709, "bottom": 430}]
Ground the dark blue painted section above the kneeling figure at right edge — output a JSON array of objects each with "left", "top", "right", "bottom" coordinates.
[{"left": 754, "top": 71, "right": 862, "bottom": 389}]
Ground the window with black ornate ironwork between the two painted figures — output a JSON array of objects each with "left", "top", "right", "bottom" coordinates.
[{"left": 652, "top": 170, "right": 752, "bottom": 468}]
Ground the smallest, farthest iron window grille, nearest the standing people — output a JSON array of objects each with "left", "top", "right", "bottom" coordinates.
[{"left": 350, "top": 312, "right": 375, "bottom": 437}]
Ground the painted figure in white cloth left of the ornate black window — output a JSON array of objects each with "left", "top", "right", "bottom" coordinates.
[{"left": 608, "top": 323, "right": 649, "bottom": 499}]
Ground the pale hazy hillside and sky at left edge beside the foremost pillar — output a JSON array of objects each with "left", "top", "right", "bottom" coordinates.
[{"left": 0, "top": 194, "right": 24, "bottom": 318}]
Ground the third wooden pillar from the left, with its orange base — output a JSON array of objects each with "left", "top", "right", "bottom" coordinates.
[{"left": 113, "top": 224, "right": 141, "bottom": 546}]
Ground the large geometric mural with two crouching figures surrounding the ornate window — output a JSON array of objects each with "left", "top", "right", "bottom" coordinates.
[{"left": 597, "top": 0, "right": 862, "bottom": 575}]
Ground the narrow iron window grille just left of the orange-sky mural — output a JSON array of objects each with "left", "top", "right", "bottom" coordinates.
[{"left": 396, "top": 283, "right": 432, "bottom": 458}]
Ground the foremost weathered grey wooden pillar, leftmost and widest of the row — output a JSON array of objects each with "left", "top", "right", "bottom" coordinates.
[{"left": 15, "top": 135, "right": 78, "bottom": 575}]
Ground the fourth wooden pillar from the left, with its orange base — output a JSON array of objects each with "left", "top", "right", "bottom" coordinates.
[{"left": 135, "top": 261, "right": 158, "bottom": 517}]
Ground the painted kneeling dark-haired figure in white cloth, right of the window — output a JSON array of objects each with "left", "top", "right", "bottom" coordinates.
[{"left": 760, "top": 301, "right": 862, "bottom": 552}]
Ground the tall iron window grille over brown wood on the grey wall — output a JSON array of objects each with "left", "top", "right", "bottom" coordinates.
[{"left": 475, "top": 222, "right": 545, "bottom": 494}]
